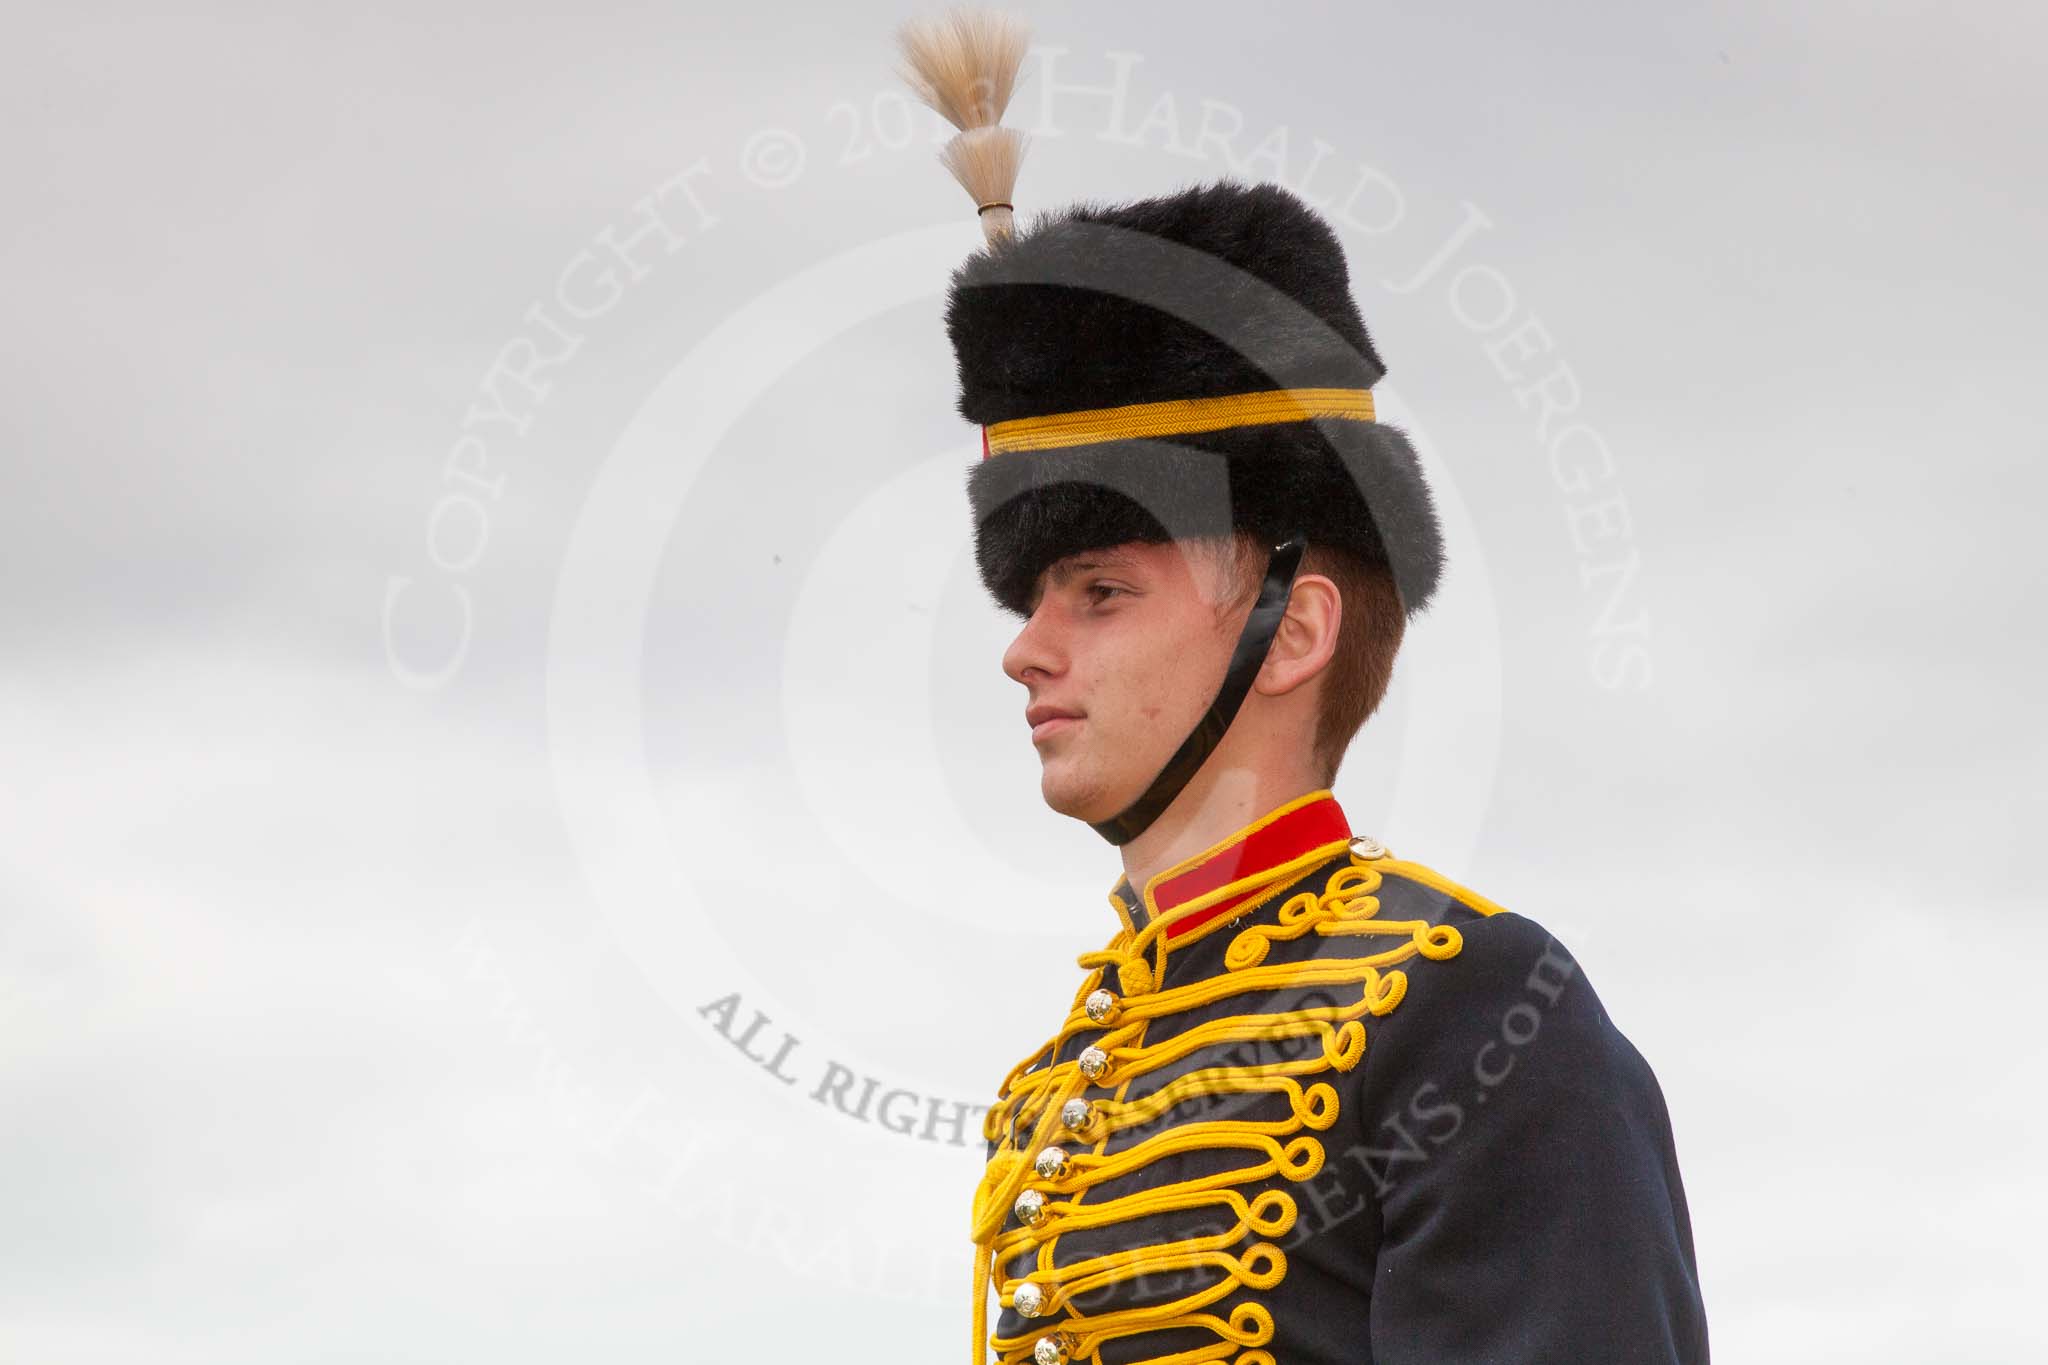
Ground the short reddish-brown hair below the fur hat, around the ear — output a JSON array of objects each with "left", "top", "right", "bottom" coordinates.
[{"left": 1196, "top": 532, "right": 1407, "bottom": 782}]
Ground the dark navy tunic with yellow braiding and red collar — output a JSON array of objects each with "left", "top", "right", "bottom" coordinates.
[{"left": 975, "top": 792, "right": 1708, "bottom": 1365}]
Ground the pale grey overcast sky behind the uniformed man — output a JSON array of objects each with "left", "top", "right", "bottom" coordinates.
[{"left": 0, "top": 0, "right": 2048, "bottom": 1365}]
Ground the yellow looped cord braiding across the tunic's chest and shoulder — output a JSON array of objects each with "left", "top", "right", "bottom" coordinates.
[{"left": 969, "top": 839, "right": 1499, "bottom": 1365}]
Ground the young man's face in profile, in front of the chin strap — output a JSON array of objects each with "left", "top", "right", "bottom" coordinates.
[{"left": 1004, "top": 542, "right": 1249, "bottom": 821}]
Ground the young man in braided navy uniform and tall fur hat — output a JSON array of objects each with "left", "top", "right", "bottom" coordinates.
[{"left": 907, "top": 16, "right": 1708, "bottom": 1365}]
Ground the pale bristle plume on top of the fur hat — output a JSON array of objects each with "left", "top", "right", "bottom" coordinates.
[{"left": 897, "top": 10, "right": 1030, "bottom": 244}]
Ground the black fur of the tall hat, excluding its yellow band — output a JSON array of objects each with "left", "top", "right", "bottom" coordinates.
[{"left": 946, "top": 180, "right": 1444, "bottom": 614}]
